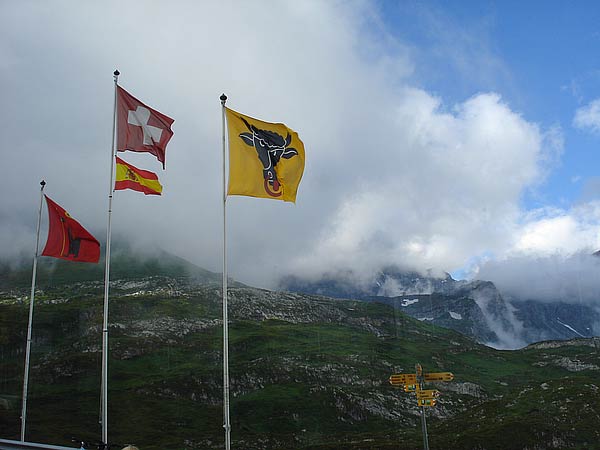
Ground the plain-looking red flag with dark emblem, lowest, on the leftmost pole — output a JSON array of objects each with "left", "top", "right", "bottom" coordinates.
[{"left": 42, "top": 195, "right": 100, "bottom": 263}]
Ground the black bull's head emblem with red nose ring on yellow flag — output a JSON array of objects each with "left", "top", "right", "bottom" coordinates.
[{"left": 240, "top": 117, "right": 298, "bottom": 197}]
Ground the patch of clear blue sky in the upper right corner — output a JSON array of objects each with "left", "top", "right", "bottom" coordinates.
[{"left": 380, "top": 0, "right": 600, "bottom": 208}]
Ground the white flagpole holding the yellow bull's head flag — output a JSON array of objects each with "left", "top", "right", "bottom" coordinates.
[{"left": 220, "top": 94, "right": 231, "bottom": 450}]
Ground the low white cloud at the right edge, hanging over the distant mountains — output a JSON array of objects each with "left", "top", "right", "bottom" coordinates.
[{"left": 476, "top": 202, "right": 600, "bottom": 305}]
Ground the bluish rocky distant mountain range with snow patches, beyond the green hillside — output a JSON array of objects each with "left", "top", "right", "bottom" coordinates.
[{"left": 279, "top": 268, "right": 600, "bottom": 348}]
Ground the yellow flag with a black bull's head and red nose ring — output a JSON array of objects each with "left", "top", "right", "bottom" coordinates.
[{"left": 225, "top": 108, "right": 304, "bottom": 202}]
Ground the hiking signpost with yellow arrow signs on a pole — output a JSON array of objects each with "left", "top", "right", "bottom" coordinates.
[{"left": 390, "top": 364, "right": 454, "bottom": 450}]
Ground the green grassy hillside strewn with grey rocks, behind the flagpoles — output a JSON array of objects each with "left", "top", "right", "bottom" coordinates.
[{"left": 0, "top": 255, "right": 600, "bottom": 450}]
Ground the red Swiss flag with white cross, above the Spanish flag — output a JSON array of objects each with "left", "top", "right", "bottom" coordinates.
[{"left": 117, "top": 86, "right": 175, "bottom": 169}]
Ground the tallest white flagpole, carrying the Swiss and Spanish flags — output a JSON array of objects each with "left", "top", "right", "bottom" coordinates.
[{"left": 101, "top": 70, "right": 120, "bottom": 445}]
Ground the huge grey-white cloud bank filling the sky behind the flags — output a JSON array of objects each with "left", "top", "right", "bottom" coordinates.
[{"left": 0, "top": 0, "right": 597, "bottom": 298}]
